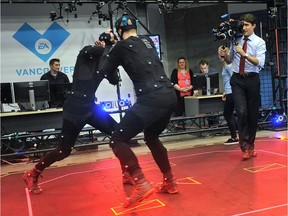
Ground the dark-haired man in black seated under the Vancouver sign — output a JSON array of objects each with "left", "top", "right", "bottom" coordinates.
[{"left": 40, "top": 58, "right": 71, "bottom": 108}]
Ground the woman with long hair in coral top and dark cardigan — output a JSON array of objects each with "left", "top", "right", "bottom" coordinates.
[{"left": 171, "top": 56, "right": 193, "bottom": 116}]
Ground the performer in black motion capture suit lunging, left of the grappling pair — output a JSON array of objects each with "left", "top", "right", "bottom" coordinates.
[{"left": 23, "top": 32, "right": 119, "bottom": 193}]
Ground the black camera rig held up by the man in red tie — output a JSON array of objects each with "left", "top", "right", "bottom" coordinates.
[{"left": 212, "top": 20, "right": 243, "bottom": 42}]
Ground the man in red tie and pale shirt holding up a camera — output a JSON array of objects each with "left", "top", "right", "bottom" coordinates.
[{"left": 218, "top": 14, "right": 266, "bottom": 160}]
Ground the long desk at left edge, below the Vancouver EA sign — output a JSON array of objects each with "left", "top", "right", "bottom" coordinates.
[{"left": 0, "top": 108, "right": 63, "bottom": 135}]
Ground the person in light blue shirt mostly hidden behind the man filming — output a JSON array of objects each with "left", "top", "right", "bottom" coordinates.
[{"left": 219, "top": 47, "right": 239, "bottom": 145}]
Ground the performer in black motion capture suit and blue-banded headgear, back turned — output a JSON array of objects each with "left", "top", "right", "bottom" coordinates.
[{"left": 100, "top": 15, "right": 179, "bottom": 208}]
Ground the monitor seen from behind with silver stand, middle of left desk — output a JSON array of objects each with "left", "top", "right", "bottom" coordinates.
[{"left": 13, "top": 80, "right": 50, "bottom": 111}]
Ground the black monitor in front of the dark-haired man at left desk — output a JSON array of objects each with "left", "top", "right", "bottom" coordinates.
[{"left": 49, "top": 83, "right": 72, "bottom": 108}]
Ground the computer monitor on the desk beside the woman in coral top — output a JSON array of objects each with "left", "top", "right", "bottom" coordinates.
[{"left": 193, "top": 72, "right": 219, "bottom": 95}]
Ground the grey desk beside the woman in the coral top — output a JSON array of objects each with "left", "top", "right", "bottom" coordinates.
[{"left": 184, "top": 95, "right": 224, "bottom": 116}]
